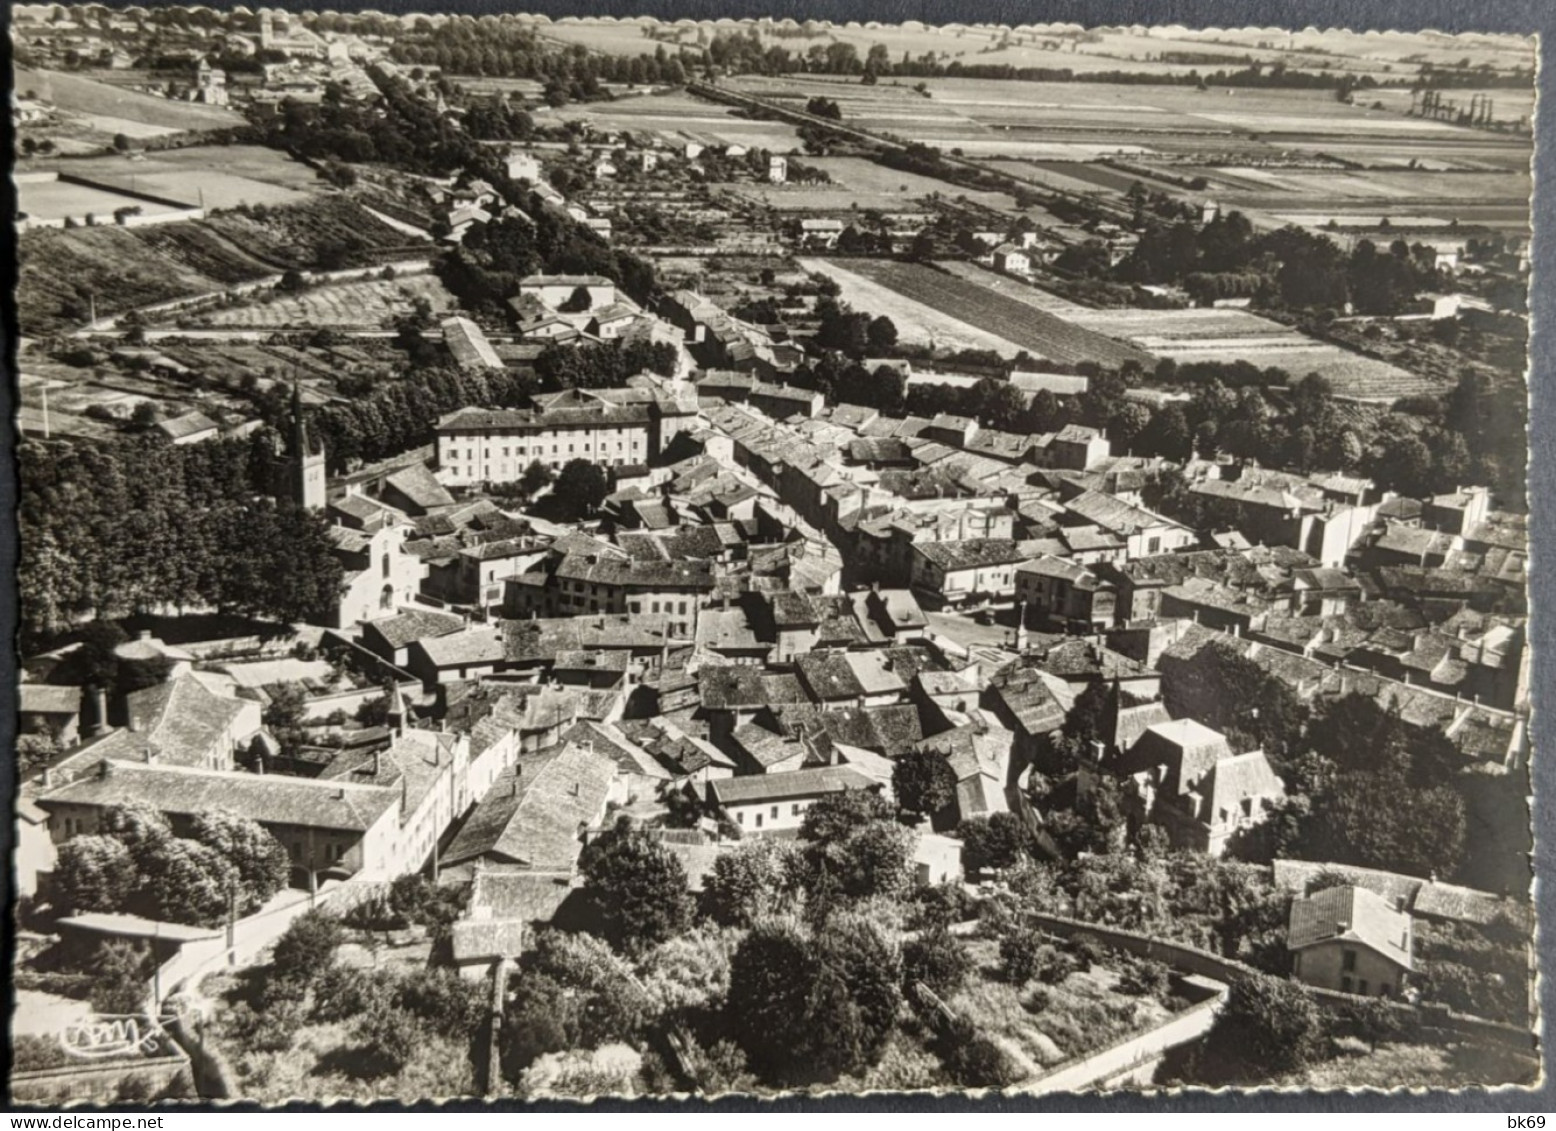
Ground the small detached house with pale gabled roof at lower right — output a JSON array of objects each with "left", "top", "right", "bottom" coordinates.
[{"left": 1285, "top": 884, "right": 1414, "bottom": 997}]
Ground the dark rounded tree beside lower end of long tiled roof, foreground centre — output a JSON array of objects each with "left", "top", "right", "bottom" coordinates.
[{"left": 579, "top": 817, "right": 692, "bottom": 952}]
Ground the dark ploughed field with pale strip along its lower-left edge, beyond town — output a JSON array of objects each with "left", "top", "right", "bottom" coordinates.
[{"left": 806, "top": 260, "right": 1150, "bottom": 366}]
